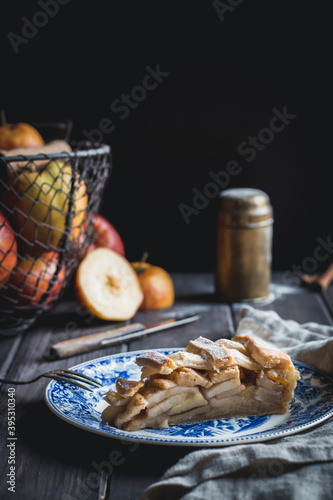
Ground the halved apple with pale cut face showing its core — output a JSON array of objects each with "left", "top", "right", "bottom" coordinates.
[{"left": 75, "top": 248, "right": 143, "bottom": 321}]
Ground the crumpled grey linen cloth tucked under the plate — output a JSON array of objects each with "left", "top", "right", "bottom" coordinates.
[{"left": 140, "top": 306, "right": 333, "bottom": 500}]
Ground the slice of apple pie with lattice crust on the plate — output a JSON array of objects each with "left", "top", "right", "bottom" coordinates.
[{"left": 102, "top": 335, "right": 299, "bottom": 431}]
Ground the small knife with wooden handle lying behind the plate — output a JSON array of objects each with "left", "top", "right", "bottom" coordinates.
[{"left": 48, "top": 314, "right": 200, "bottom": 359}]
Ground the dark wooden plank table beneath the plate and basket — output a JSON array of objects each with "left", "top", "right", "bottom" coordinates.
[{"left": 0, "top": 273, "right": 333, "bottom": 500}]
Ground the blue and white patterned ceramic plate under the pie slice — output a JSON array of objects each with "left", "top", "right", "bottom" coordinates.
[{"left": 45, "top": 349, "right": 333, "bottom": 447}]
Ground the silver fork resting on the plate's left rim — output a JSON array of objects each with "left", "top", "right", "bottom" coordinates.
[{"left": 0, "top": 369, "right": 103, "bottom": 392}]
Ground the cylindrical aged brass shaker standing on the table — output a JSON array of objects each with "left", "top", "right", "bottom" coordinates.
[{"left": 215, "top": 188, "right": 273, "bottom": 303}]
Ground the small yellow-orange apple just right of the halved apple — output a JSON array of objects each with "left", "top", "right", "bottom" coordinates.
[{"left": 132, "top": 261, "right": 175, "bottom": 310}]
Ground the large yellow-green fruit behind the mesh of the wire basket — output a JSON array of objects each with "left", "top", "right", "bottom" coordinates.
[{"left": 4, "top": 161, "right": 88, "bottom": 255}]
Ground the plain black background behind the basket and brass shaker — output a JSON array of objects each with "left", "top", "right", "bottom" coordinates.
[{"left": 0, "top": 0, "right": 332, "bottom": 271}]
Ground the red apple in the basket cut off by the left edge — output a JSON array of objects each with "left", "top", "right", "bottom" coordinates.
[{"left": 0, "top": 212, "right": 17, "bottom": 290}]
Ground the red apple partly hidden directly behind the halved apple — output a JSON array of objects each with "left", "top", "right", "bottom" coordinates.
[{"left": 88, "top": 214, "right": 125, "bottom": 257}]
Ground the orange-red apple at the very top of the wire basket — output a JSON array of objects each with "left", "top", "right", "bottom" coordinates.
[{"left": 0, "top": 112, "right": 45, "bottom": 150}]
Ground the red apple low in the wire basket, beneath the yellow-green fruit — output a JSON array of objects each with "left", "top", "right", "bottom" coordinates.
[{"left": 8, "top": 252, "right": 66, "bottom": 310}]
